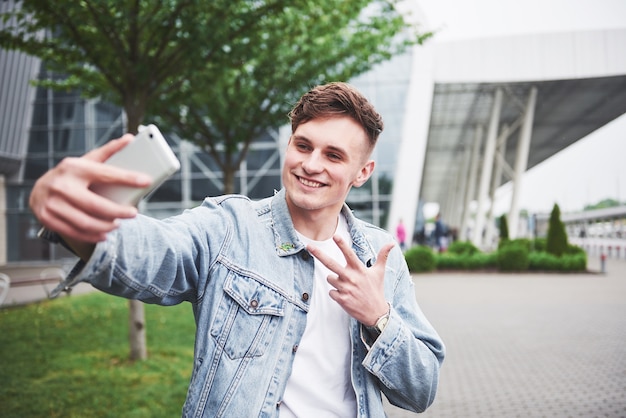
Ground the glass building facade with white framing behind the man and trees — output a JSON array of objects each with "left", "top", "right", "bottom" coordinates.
[{"left": 0, "top": 50, "right": 411, "bottom": 263}]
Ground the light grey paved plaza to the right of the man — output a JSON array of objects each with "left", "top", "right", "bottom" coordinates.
[{"left": 387, "top": 258, "right": 626, "bottom": 418}]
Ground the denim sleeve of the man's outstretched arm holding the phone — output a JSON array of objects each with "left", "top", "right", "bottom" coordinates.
[{"left": 60, "top": 205, "right": 222, "bottom": 305}]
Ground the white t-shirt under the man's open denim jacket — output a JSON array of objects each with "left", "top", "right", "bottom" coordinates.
[{"left": 280, "top": 216, "right": 357, "bottom": 418}]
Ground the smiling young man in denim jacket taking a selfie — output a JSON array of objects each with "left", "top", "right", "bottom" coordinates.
[{"left": 30, "top": 83, "right": 444, "bottom": 418}]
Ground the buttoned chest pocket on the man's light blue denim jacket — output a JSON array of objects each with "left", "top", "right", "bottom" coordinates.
[{"left": 210, "top": 271, "right": 285, "bottom": 359}]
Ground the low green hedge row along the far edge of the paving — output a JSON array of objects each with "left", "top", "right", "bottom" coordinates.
[{"left": 404, "top": 239, "right": 587, "bottom": 273}]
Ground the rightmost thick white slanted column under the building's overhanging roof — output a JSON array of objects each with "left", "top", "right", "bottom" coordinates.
[{"left": 509, "top": 87, "right": 537, "bottom": 239}]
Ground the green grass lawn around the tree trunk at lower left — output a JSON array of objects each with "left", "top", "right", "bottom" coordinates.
[{"left": 0, "top": 292, "right": 195, "bottom": 418}]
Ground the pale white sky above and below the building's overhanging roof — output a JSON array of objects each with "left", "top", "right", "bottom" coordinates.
[{"left": 418, "top": 0, "right": 626, "bottom": 213}]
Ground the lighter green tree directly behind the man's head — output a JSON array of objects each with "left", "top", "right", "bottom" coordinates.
[{"left": 157, "top": 0, "right": 430, "bottom": 193}]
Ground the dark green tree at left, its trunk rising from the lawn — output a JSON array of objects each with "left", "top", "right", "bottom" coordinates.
[{"left": 0, "top": 0, "right": 282, "bottom": 360}]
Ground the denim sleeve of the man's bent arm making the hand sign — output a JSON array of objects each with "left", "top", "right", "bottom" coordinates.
[{"left": 362, "top": 250, "right": 445, "bottom": 412}]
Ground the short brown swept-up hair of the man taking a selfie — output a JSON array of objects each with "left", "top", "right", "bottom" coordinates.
[{"left": 289, "top": 82, "right": 383, "bottom": 148}]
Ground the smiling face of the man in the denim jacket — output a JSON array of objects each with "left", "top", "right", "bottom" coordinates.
[{"left": 282, "top": 117, "right": 374, "bottom": 218}]
